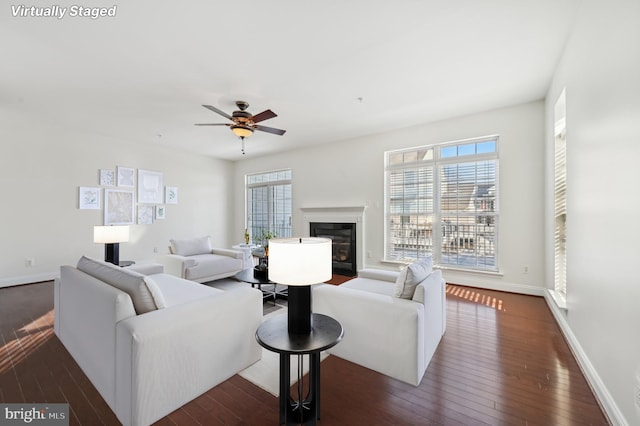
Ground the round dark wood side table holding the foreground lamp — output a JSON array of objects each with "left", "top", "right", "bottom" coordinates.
[{"left": 256, "top": 313, "right": 344, "bottom": 425}]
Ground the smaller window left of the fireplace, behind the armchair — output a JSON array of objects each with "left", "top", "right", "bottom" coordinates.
[{"left": 246, "top": 169, "right": 291, "bottom": 238}]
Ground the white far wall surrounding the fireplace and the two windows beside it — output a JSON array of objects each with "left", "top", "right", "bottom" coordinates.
[{"left": 234, "top": 101, "right": 545, "bottom": 294}]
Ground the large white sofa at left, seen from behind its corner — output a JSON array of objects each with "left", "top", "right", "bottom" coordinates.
[{"left": 54, "top": 257, "right": 262, "bottom": 426}]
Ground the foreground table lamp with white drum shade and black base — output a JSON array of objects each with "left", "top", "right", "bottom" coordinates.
[{"left": 269, "top": 238, "right": 332, "bottom": 334}]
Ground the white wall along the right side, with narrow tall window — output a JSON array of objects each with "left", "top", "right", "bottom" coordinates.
[{"left": 545, "top": 0, "right": 640, "bottom": 424}]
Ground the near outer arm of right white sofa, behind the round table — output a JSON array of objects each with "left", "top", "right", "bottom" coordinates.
[{"left": 312, "top": 285, "right": 426, "bottom": 385}]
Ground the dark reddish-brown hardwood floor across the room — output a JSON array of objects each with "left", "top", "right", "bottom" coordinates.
[{"left": 0, "top": 282, "right": 608, "bottom": 425}]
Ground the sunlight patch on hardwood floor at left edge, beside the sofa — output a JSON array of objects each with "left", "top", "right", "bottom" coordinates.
[{"left": 0, "top": 309, "right": 54, "bottom": 374}]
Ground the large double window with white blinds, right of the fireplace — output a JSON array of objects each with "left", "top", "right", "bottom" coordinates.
[{"left": 385, "top": 136, "right": 498, "bottom": 271}]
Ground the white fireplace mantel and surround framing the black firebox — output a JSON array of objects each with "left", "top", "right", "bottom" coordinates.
[{"left": 300, "top": 206, "right": 366, "bottom": 271}]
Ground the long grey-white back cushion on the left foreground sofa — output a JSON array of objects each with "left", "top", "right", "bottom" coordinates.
[{"left": 77, "top": 256, "right": 159, "bottom": 315}]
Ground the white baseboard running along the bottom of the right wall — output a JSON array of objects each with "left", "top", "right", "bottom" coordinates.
[{"left": 544, "top": 289, "right": 629, "bottom": 426}]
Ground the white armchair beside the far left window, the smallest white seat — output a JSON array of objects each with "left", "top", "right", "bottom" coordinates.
[{"left": 157, "top": 236, "right": 246, "bottom": 283}]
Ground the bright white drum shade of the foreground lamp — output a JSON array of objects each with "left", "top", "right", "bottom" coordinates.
[{"left": 269, "top": 238, "right": 332, "bottom": 285}]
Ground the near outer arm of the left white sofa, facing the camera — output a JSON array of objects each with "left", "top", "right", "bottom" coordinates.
[{"left": 115, "top": 287, "right": 262, "bottom": 425}]
